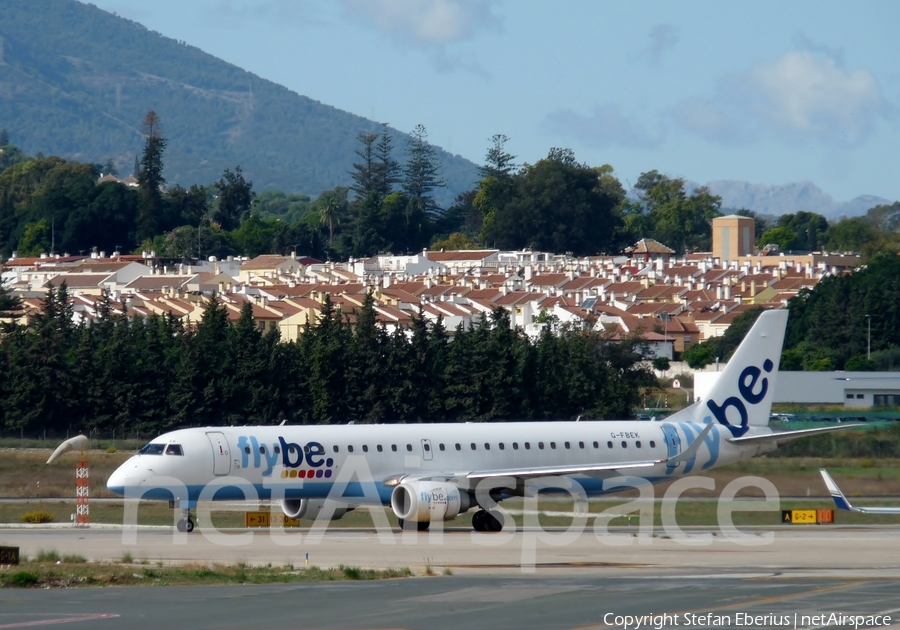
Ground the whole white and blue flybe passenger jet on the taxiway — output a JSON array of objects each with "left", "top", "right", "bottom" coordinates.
[{"left": 107, "top": 310, "right": 852, "bottom": 531}]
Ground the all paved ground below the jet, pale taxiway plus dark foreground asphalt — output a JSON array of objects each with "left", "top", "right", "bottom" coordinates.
[{"left": 0, "top": 526, "right": 900, "bottom": 630}]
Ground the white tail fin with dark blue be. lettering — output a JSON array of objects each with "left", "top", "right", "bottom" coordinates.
[{"left": 667, "top": 310, "right": 788, "bottom": 437}]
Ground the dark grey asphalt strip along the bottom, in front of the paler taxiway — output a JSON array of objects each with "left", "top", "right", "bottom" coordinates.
[{"left": 0, "top": 573, "right": 900, "bottom": 630}]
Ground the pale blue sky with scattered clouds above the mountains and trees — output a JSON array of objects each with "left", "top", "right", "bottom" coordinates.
[{"left": 86, "top": 0, "right": 900, "bottom": 201}]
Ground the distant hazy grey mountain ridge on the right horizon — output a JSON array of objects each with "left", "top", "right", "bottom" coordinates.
[{"left": 688, "top": 180, "right": 892, "bottom": 219}]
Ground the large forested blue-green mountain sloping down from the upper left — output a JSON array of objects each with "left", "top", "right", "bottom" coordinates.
[{"left": 0, "top": 0, "right": 478, "bottom": 207}]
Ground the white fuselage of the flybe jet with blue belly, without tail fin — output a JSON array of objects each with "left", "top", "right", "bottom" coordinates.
[{"left": 108, "top": 421, "right": 770, "bottom": 505}]
